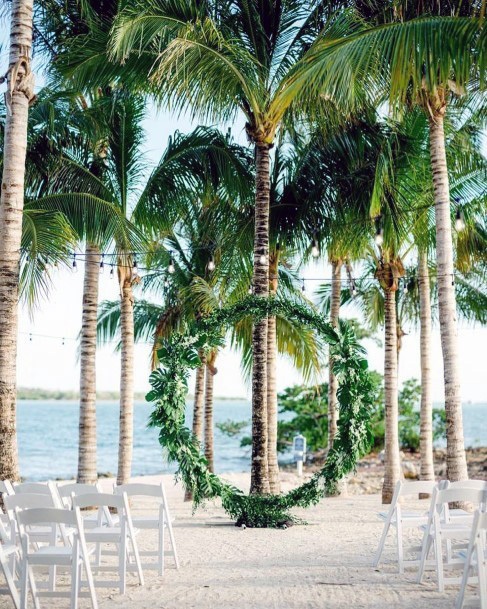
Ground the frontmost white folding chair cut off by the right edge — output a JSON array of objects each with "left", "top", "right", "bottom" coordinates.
[{"left": 455, "top": 510, "right": 487, "bottom": 609}]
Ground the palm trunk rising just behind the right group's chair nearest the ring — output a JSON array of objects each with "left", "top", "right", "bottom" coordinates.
[{"left": 382, "top": 290, "right": 401, "bottom": 503}]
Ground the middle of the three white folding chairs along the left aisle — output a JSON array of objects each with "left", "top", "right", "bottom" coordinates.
[{"left": 72, "top": 493, "right": 144, "bottom": 594}]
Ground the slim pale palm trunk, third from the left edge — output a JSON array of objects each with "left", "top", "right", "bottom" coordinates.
[{"left": 117, "top": 268, "right": 134, "bottom": 484}]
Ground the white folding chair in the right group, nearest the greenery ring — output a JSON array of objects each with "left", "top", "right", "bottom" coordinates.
[{"left": 373, "top": 480, "right": 436, "bottom": 573}]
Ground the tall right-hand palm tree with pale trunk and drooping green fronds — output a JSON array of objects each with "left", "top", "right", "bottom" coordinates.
[{"left": 295, "top": 2, "right": 487, "bottom": 480}]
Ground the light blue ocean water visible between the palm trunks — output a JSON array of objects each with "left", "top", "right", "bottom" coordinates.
[{"left": 17, "top": 400, "right": 487, "bottom": 480}]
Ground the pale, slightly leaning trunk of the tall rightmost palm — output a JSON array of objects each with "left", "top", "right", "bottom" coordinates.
[{"left": 430, "top": 113, "right": 468, "bottom": 481}]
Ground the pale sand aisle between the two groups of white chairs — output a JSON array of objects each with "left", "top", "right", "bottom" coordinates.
[{"left": 41, "top": 472, "right": 468, "bottom": 609}]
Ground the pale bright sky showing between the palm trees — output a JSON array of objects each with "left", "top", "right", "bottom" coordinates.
[{"left": 0, "top": 23, "right": 487, "bottom": 402}]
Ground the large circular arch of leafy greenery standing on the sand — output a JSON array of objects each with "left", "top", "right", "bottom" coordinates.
[{"left": 146, "top": 296, "right": 372, "bottom": 527}]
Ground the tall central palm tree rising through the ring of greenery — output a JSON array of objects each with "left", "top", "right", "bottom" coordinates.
[{"left": 113, "top": 0, "right": 358, "bottom": 494}]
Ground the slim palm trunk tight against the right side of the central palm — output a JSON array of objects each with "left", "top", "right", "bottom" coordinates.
[{"left": 267, "top": 250, "right": 281, "bottom": 495}]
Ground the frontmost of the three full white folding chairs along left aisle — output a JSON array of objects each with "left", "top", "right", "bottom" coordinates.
[{"left": 15, "top": 508, "right": 98, "bottom": 609}]
